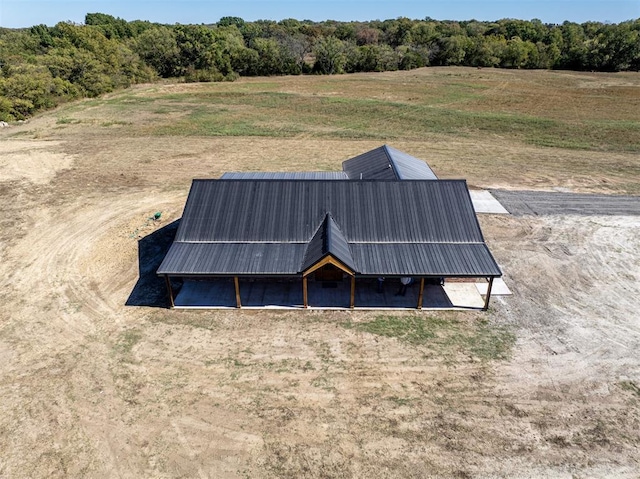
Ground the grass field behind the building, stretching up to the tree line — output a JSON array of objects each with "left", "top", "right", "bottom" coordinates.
[{"left": 38, "top": 68, "right": 640, "bottom": 194}]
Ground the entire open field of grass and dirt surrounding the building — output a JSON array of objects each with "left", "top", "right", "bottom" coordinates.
[{"left": 0, "top": 68, "right": 640, "bottom": 478}]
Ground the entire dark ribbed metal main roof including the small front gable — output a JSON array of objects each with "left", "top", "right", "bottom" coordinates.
[{"left": 158, "top": 180, "right": 501, "bottom": 276}]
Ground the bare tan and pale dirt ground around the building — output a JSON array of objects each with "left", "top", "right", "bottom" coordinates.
[{"left": 0, "top": 86, "right": 640, "bottom": 478}]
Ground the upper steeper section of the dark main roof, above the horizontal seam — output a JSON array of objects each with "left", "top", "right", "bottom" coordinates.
[{"left": 176, "top": 180, "right": 483, "bottom": 243}]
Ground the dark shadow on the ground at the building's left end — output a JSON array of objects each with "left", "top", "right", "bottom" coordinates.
[{"left": 125, "top": 219, "right": 180, "bottom": 308}]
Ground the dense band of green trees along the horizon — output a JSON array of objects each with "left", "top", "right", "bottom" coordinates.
[{"left": 0, "top": 13, "right": 640, "bottom": 121}]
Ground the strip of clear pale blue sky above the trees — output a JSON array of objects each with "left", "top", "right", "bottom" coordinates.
[{"left": 0, "top": 0, "right": 640, "bottom": 28}]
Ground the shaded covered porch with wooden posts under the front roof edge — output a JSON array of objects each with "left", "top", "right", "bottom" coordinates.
[{"left": 168, "top": 275, "right": 492, "bottom": 310}]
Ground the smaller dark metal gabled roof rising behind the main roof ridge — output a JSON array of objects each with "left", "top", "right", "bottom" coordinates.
[{"left": 342, "top": 145, "right": 438, "bottom": 180}]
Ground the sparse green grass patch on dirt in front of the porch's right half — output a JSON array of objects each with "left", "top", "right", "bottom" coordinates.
[{"left": 342, "top": 315, "right": 515, "bottom": 361}]
